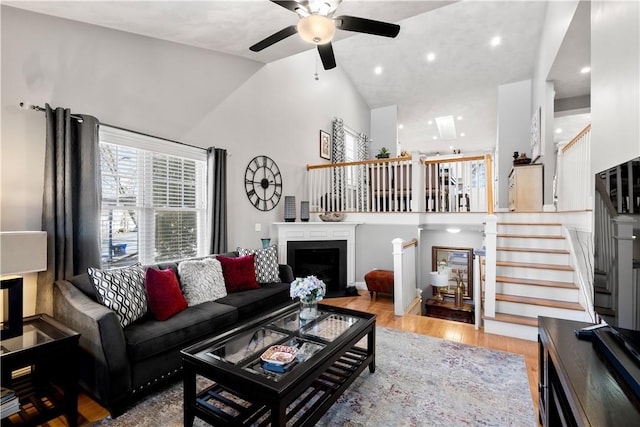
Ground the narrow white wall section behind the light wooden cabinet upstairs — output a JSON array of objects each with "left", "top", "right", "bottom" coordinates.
[{"left": 494, "top": 80, "right": 532, "bottom": 209}]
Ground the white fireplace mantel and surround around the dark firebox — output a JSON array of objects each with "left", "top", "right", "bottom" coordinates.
[{"left": 273, "top": 222, "right": 362, "bottom": 286}]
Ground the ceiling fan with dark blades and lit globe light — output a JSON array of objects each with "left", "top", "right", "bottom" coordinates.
[{"left": 249, "top": 0, "right": 400, "bottom": 70}]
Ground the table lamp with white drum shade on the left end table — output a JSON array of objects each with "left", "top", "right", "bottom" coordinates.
[{"left": 0, "top": 231, "right": 47, "bottom": 340}]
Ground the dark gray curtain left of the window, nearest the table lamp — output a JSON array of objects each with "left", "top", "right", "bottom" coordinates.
[{"left": 36, "top": 104, "right": 101, "bottom": 314}]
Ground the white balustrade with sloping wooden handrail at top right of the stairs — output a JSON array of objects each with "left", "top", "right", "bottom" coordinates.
[{"left": 556, "top": 124, "right": 593, "bottom": 211}]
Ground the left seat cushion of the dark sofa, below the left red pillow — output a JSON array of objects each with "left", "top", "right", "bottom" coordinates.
[{"left": 124, "top": 301, "right": 238, "bottom": 362}]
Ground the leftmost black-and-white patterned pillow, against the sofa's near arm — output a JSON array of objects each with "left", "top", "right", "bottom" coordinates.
[{"left": 87, "top": 263, "right": 147, "bottom": 328}]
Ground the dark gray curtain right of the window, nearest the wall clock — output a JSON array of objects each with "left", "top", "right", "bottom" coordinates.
[{"left": 207, "top": 147, "right": 227, "bottom": 254}]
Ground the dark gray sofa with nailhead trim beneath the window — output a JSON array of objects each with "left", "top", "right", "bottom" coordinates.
[{"left": 53, "top": 253, "right": 294, "bottom": 417}]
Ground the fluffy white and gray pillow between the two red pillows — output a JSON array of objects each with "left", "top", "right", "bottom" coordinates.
[{"left": 178, "top": 258, "right": 227, "bottom": 306}]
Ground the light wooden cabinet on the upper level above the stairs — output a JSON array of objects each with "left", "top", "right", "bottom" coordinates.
[{"left": 509, "top": 165, "right": 542, "bottom": 212}]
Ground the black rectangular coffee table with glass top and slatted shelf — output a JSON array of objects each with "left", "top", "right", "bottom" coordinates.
[{"left": 181, "top": 304, "right": 376, "bottom": 426}]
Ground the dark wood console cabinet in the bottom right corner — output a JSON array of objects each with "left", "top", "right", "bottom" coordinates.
[{"left": 538, "top": 317, "right": 640, "bottom": 426}]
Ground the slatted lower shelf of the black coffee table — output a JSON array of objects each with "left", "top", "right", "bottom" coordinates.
[{"left": 193, "top": 347, "right": 373, "bottom": 427}]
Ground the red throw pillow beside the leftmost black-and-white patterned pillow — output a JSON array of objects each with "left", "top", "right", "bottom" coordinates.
[{"left": 144, "top": 268, "right": 187, "bottom": 320}]
